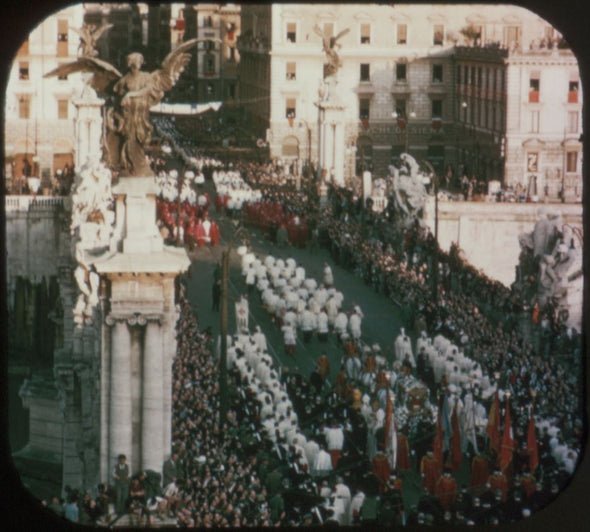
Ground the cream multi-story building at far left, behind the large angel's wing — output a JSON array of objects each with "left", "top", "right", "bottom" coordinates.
[{"left": 4, "top": 5, "right": 83, "bottom": 190}]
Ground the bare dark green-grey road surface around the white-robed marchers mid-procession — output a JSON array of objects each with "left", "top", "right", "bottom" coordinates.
[{"left": 180, "top": 184, "right": 476, "bottom": 509}]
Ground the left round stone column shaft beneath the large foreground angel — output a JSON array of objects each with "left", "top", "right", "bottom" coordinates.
[{"left": 109, "top": 319, "right": 132, "bottom": 472}]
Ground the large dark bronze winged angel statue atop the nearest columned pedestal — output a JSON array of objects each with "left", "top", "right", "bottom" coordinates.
[{"left": 45, "top": 39, "right": 202, "bottom": 177}]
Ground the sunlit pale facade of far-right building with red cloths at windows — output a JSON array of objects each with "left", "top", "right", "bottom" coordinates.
[{"left": 504, "top": 43, "right": 582, "bottom": 201}]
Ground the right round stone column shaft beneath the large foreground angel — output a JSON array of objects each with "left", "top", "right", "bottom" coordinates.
[{"left": 141, "top": 320, "right": 167, "bottom": 471}]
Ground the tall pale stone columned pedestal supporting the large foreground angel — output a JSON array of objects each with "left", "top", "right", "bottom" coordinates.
[{"left": 94, "top": 177, "right": 190, "bottom": 481}]
